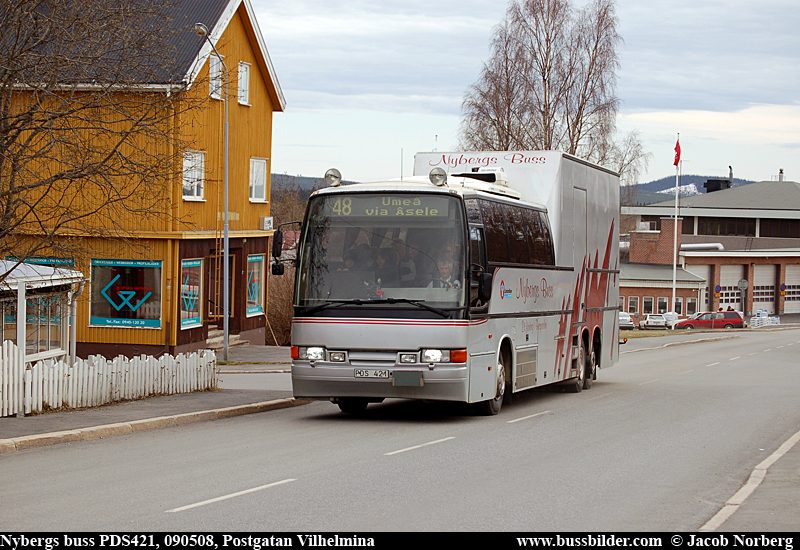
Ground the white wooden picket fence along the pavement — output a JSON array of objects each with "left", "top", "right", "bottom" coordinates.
[{"left": 0, "top": 341, "right": 218, "bottom": 417}]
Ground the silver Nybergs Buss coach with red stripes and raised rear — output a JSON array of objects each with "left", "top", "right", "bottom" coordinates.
[{"left": 272, "top": 151, "right": 619, "bottom": 415}]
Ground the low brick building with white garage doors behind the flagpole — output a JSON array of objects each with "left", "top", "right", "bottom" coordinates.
[{"left": 620, "top": 176, "right": 800, "bottom": 315}]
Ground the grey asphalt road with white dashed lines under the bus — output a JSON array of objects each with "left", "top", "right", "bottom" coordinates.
[{"left": 0, "top": 330, "right": 800, "bottom": 532}]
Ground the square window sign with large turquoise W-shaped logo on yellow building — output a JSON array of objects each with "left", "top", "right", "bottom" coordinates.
[{"left": 89, "top": 260, "right": 161, "bottom": 328}]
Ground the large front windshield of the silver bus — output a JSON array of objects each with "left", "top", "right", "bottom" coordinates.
[{"left": 295, "top": 192, "right": 469, "bottom": 311}]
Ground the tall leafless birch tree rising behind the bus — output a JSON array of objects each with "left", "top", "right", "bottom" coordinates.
[{"left": 460, "top": 0, "right": 649, "bottom": 180}]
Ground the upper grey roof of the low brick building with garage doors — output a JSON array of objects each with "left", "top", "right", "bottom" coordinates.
[{"left": 623, "top": 181, "right": 800, "bottom": 218}]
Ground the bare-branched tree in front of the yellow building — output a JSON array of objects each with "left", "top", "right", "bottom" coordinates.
[{"left": 0, "top": 0, "right": 199, "bottom": 280}]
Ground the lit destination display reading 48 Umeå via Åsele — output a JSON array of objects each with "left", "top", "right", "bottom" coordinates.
[{"left": 328, "top": 194, "right": 451, "bottom": 218}]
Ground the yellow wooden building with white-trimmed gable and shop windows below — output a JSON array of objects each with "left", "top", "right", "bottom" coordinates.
[{"left": 8, "top": 0, "right": 285, "bottom": 357}]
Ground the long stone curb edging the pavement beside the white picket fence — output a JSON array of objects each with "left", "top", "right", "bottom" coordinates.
[{"left": 0, "top": 398, "right": 311, "bottom": 455}]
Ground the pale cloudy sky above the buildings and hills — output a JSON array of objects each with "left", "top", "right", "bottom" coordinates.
[{"left": 251, "top": 0, "right": 800, "bottom": 183}]
